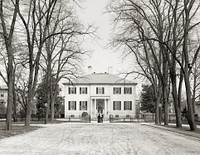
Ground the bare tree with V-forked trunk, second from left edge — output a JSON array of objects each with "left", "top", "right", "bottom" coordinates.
[{"left": 18, "top": 0, "right": 65, "bottom": 126}]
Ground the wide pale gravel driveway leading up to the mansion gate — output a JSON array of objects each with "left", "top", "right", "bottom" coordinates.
[{"left": 0, "top": 123, "right": 200, "bottom": 155}]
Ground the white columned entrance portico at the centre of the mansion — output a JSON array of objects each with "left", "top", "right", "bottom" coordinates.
[{"left": 90, "top": 96, "right": 110, "bottom": 118}]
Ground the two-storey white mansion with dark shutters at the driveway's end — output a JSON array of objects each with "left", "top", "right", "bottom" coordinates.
[{"left": 64, "top": 73, "right": 137, "bottom": 119}]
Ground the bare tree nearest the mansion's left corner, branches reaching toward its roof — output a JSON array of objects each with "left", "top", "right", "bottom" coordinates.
[{"left": 43, "top": 1, "right": 91, "bottom": 121}]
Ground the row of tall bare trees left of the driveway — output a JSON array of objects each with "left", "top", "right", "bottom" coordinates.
[{"left": 0, "top": 0, "right": 91, "bottom": 130}]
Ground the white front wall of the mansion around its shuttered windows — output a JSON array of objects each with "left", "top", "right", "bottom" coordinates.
[{"left": 65, "top": 85, "right": 136, "bottom": 117}]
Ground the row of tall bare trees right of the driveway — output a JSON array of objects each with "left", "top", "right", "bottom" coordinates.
[{"left": 108, "top": 0, "right": 200, "bottom": 130}]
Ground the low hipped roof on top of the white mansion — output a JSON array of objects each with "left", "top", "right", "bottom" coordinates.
[{"left": 63, "top": 73, "right": 137, "bottom": 85}]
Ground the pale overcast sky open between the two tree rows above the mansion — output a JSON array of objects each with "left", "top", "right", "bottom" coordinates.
[{"left": 77, "top": 0, "right": 134, "bottom": 74}]
